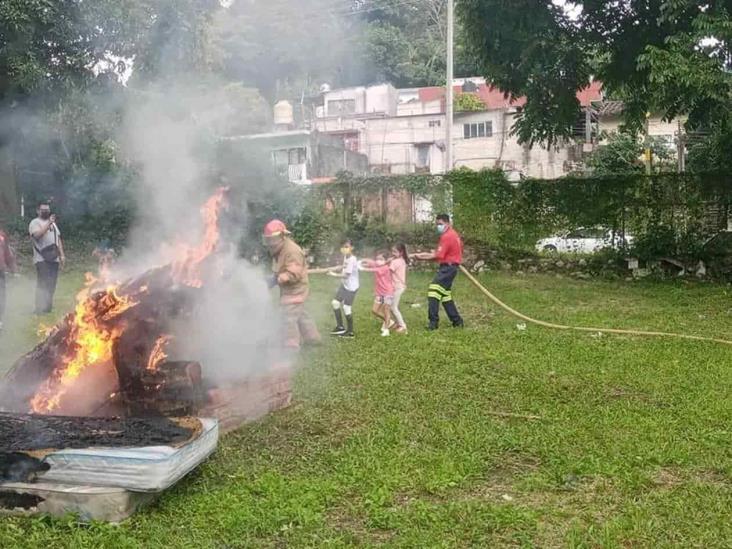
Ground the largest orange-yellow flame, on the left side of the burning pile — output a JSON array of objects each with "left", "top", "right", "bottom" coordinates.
[{"left": 31, "top": 287, "right": 138, "bottom": 413}]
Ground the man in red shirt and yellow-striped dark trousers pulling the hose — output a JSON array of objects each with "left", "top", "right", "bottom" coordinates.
[{"left": 412, "top": 214, "right": 464, "bottom": 330}]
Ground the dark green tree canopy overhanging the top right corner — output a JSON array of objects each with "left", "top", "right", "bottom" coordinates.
[{"left": 458, "top": 0, "right": 732, "bottom": 143}]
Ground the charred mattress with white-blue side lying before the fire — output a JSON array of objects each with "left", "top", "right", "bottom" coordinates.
[{"left": 0, "top": 416, "right": 218, "bottom": 492}]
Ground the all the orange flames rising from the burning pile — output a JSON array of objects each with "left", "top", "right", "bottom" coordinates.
[{"left": 30, "top": 188, "right": 228, "bottom": 414}]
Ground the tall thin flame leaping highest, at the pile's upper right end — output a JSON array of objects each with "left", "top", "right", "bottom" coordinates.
[{"left": 173, "top": 187, "right": 229, "bottom": 288}]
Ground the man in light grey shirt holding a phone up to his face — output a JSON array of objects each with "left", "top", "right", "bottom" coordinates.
[{"left": 28, "top": 202, "right": 66, "bottom": 314}]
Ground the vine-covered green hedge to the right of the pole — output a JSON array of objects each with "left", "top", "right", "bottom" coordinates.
[{"left": 448, "top": 170, "right": 732, "bottom": 259}]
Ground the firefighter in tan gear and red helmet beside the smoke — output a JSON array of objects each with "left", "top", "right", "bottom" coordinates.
[{"left": 264, "top": 219, "right": 320, "bottom": 349}]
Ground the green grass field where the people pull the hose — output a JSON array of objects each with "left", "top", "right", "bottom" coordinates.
[{"left": 0, "top": 268, "right": 732, "bottom": 548}]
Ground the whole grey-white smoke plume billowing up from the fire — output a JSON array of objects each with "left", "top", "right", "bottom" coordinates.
[{"left": 0, "top": 0, "right": 372, "bottom": 396}]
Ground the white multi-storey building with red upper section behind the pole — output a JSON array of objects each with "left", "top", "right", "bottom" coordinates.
[{"left": 314, "top": 78, "right": 600, "bottom": 178}]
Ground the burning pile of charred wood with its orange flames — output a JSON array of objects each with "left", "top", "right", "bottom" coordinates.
[{"left": 0, "top": 188, "right": 289, "bottom": 419}]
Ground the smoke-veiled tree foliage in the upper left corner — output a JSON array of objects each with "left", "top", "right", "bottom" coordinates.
[{"left": 0, "top": 0, "right": 221, "bottom": 218}]
